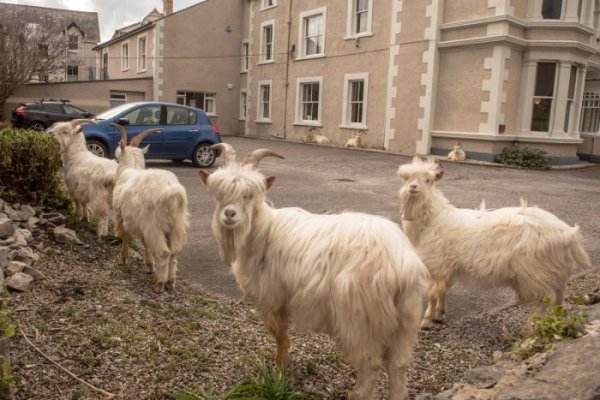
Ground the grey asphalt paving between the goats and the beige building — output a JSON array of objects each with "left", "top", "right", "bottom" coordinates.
[{"left": 148, "top": 137, "right": 600, "bottom": 316}]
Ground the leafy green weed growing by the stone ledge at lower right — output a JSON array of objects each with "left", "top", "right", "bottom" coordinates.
[{"left": 506, "top": 298, "right": 586, "bottom": 360}]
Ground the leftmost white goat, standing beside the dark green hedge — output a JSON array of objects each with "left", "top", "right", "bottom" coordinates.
[{"left": 52, "top": 119, "right": 117, "bottom": 237}]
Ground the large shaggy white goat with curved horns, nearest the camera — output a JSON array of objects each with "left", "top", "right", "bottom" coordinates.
[{"left": 199, "top": 143, "right": 428, "bottom": 400}]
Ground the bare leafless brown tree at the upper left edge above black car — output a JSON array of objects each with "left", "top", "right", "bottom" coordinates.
[{"left": 0, "top": 8, "right": 67, "bottom": 119}]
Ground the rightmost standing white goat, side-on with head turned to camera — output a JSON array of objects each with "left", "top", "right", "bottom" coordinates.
[{"left": 398, "top": 157, "right": 591, "bottom": 327}]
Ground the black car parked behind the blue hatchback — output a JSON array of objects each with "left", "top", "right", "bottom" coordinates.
[{"left": 11, "top": 99, "right": 94, "bottom": 130}]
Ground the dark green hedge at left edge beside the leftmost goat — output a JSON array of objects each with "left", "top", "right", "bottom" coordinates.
[{"left": 0, "top": 127, "right": 69, "bottom": 209}]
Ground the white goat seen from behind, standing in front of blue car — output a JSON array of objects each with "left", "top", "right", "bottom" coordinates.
[{"left": 113, "top": 124, "right": 189, "bottom": 292}]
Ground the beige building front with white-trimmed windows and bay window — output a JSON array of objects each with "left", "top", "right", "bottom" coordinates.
[{"left": 240, "top": 0, "right": 600, "bottom": 164}]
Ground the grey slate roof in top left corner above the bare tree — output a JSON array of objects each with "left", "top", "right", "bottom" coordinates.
[{"left": 0, "top": 3, "right": 100, "bottom": 43}]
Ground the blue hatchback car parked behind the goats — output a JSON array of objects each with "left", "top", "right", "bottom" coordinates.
[{"left": 82, "top": 102, "right": 221, "bottom": 168}]
